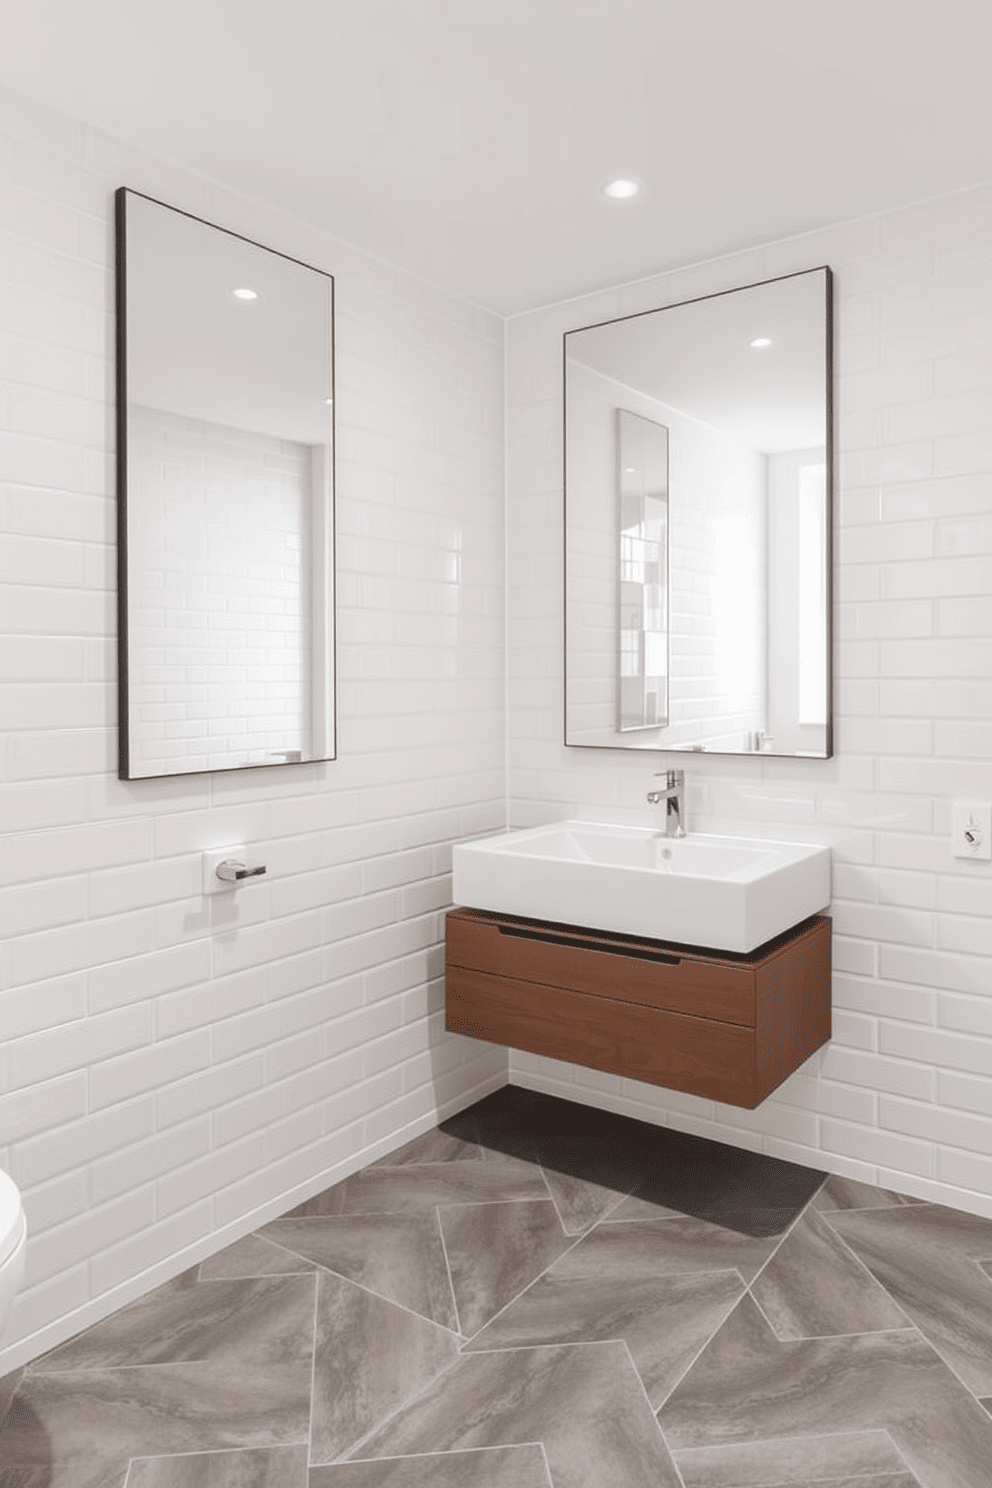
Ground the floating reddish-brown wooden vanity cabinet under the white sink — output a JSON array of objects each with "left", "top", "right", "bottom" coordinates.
[{"left": 445, "top": 909, "right": 830, "bottom": 1110}]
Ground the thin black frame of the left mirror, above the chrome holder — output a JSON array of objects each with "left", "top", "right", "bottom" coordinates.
[{"left": 115, "top": 186, "right": 338, "bottom": 780}]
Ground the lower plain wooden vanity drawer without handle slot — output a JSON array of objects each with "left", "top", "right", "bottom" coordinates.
[{"left": 445, "top": 967, "right": 757, "bottom": 1107}]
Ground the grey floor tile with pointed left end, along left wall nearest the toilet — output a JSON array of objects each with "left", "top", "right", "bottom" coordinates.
[{"left": 28, "top": 1275, "right": 314, "bottom": 1375}]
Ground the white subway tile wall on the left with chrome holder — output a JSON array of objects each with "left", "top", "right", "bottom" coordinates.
[{"left": 0, "top": 91, "right": 507, "bottom": 1375}]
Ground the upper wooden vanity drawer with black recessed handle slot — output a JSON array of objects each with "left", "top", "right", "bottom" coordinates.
[{"left": 445, "top": 909, "right": 757, "bottom": 1027}]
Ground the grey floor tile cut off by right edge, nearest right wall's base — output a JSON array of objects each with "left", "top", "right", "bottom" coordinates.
[{"left": 825, "top": 1204, "right": 992, "bottom": 1396}]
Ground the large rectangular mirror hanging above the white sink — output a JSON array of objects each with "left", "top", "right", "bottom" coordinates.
[{"left": 564, "top": 268, "right": 833, "bottom": 759}]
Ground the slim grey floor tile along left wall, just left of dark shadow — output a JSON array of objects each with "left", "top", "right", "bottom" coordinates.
[{"left": 284, "top": 1156, "right": 547, "bottom": 1219}]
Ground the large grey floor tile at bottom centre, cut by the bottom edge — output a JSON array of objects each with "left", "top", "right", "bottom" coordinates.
[{"left": 355, "top": 1342, "right": 681, "bottom": 1488}]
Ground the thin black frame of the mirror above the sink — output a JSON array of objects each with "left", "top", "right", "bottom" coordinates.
[{"left": 562, "top": 263, "right": 834, "bottom": 762}]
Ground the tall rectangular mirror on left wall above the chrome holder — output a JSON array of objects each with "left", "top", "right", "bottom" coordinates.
[{"left": 116, "top": 187, "right": 335, "bottom": 780}]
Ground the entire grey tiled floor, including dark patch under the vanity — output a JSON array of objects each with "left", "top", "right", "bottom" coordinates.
[{"left": 0, "top": 1088, "right": 992, "bottom": 1488}]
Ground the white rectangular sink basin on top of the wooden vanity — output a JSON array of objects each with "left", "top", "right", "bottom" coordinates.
[{"left": 454, "top": 821, "right": 830, "bottom": 954}]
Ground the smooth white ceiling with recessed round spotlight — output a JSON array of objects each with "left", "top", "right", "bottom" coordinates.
[{"left": 0, "top": 0, "right": 992, "bottom": 314}]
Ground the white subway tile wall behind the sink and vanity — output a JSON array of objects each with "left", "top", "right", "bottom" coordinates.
[{"left": 507, "top": 186, "right": 992, "bottom": 1216}]
